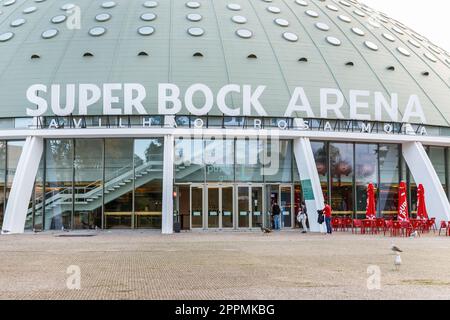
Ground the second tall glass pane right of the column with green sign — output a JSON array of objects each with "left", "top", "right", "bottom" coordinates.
[{"left": 329, "top": 143, "right": 354, "bottom": 215}]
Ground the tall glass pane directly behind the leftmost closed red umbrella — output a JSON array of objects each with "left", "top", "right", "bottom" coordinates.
[{"left": 355, "top": 144, "right": 378, "bottom": 219}]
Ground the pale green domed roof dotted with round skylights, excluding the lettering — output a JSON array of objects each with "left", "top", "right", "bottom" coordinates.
[{"left": 0, "top": 0, "right": 450, "bottom": 126}]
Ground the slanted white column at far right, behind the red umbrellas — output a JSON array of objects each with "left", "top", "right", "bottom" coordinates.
[{"left": 402, "top": 142, "right": 450, "bottom": 223}]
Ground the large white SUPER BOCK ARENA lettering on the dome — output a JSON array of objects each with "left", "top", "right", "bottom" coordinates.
[{"left": 26, "top": 83, "right": 426, "bottom": 124}]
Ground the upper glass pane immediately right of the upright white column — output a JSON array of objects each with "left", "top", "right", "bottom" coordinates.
[{"left": 174, "top": 139, "right": 205, "bottom": 182}]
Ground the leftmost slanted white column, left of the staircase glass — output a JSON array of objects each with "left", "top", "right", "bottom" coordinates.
[{"left": 2, "top": 137, "right": 44, "bottom": 234}]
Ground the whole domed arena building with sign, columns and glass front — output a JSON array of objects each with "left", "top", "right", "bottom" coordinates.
[{"left": 0, "top": 0, "right": 450, "bottom": 234}]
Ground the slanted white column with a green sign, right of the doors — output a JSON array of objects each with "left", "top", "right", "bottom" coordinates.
[{"left": 294, "top": 138, "right": 325, "bottom": 232}]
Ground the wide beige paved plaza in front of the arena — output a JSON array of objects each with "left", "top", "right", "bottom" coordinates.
[{"left": 0, "top": 231, "right": 450, "bottom": 299}]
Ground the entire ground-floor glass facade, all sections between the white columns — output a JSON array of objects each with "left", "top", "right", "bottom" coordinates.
[{"left": 4, "top": 138, "right": 450, "bottom": 230}]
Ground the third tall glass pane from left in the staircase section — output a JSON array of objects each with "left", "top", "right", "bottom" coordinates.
[{"left": 104, "top": 139, "right": 134, "bottom": 228}]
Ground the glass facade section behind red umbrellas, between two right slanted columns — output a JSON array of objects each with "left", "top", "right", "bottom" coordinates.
[{"left": 311, "top": 141, "right": 406, "bottom": 218}]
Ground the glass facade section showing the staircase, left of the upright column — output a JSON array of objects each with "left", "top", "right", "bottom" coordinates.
[{"left": 22, "top": 138, "right": 164, "bottom": 230}]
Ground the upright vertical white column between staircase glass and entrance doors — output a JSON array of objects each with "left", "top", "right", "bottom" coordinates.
[{"left": 162, "top": 135, "right": 174, "bottom": 234}]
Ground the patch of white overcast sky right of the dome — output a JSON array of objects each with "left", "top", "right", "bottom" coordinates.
[{"left": 360, "top": 0, "right": 450, "bottom": 51}]
